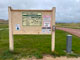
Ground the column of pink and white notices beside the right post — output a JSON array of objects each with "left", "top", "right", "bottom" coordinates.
[{"left": 42, "top": 15, "right": 51, "bottom": 33}]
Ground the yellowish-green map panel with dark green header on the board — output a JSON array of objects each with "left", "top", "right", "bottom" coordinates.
[{"left": 22, "top": 12, "right": 42, "bottom": 26}]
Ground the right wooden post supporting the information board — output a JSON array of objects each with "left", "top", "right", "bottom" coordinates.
[{"left": 51, "top": 7, "right": 56, "bottom": 52}]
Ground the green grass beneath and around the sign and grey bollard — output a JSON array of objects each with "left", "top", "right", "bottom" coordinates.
[{"left": 0, "top": 29, "right": 80, "bottom": 60}]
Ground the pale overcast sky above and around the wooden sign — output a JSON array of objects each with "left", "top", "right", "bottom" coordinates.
[{"left": 0, "top": 0, "right": 80, "bottom": 22}]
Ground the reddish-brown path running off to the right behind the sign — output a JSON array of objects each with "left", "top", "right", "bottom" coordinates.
[{"left": 56, "top": 27, "right": 80, "bottom": 37}]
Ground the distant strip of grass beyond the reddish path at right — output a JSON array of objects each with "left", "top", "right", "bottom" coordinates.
[{"left": 56, "top": 23, "right": 80, "bottom": 29}]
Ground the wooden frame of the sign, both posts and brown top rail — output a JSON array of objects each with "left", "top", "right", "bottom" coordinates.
[{"left": 8, "top": 6, "right": 56, "bottom": 52}]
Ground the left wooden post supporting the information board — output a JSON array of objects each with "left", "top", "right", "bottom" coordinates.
[{"left": 8, "top": 7, "right": 14, "bottom": 51}]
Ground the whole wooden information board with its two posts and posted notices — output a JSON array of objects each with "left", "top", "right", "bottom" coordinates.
[{"left": 8, "top": 7, "right": 56, "bottom": 52}]
